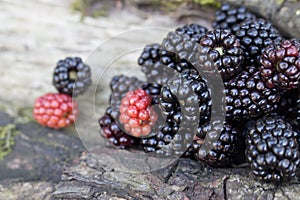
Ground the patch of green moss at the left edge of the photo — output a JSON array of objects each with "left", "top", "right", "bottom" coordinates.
[{"left": 0, "top": 124, "right": 17, "bottom": 160}]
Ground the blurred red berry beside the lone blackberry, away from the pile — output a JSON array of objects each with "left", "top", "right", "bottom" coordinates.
[{"left": 33, "top": 93, "right": 78, "bottom": 129}]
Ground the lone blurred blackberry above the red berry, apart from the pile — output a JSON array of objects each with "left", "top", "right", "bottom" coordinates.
[{"left": 52, "top": 57, "right": 92, "bottom": 97}]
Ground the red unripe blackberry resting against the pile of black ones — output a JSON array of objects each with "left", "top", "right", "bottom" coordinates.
[{"left": 119, "top": 89, "right": 157, "bottom": 137}]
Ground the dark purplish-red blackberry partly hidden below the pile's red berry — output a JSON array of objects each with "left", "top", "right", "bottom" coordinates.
[{"left": 99, "top": 107, "right": 139, "bottom": 148}]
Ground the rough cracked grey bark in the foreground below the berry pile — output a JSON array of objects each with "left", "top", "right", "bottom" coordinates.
[{"left": 53, "top": 152, "right": 300, "bottom": 200}]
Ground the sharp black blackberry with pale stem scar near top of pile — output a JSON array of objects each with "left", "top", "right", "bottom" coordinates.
[{"left": 199, "top": 29, "right": 244, "bottom": 80}]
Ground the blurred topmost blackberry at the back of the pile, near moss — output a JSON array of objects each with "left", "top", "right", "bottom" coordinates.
[{"left": 212, "top": 4, "right": 256, "bottom": 32}]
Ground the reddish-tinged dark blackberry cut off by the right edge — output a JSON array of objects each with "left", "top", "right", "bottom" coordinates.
[{"left": 260, "top": 40, "right": 300, "bottom": 91}]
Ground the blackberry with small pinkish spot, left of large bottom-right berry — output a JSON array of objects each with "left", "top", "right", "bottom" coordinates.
[{"left": 192, "top": 120, "right": 245, "bottom": 167}]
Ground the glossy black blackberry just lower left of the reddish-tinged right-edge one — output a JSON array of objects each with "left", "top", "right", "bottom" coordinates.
[{"left": 224, "top": 66, "right": 280, "bottom": 122}]
